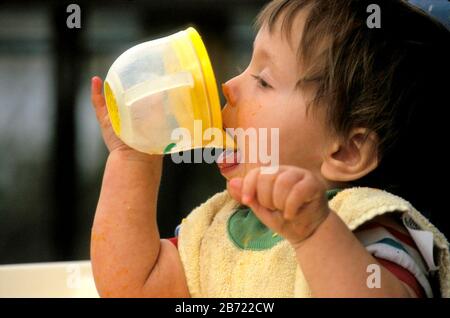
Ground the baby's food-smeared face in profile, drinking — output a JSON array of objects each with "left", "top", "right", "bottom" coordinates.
[{"left": 221, "top": 16, "right": 330, "bottom": 180}]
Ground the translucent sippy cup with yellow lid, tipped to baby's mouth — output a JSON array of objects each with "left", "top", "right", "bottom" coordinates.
[{"left": 104, "top": 27, "right": 235, "bottom": 154}]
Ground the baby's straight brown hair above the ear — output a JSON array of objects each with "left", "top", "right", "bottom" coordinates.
[{"left": 255, "top": 0, "right": 449, "bottom": 153}]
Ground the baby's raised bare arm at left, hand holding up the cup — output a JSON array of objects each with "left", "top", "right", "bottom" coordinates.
[{"left": 91, "top": 78, "right": 189, "bottom": 297}]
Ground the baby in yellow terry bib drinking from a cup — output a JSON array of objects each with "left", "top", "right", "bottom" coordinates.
[{"left": 91, "top": 0, "right": 450, "bottom": 297}]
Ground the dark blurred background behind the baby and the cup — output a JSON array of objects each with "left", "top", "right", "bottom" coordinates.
[{"left": 0, "top": 0, "right": 450, "bottom": 264}]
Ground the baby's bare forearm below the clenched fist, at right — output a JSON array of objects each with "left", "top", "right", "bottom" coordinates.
[{"left": 296, "top": 212, "right": 417, "bottom": 297}]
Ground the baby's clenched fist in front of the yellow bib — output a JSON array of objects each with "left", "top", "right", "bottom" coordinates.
[{"left": 228, "top": 166, "right": 330, "bottom": 249}]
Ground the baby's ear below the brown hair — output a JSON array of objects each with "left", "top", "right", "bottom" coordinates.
[{"left": 321, "top": 128, "right": 379, "bottom": 182}]
